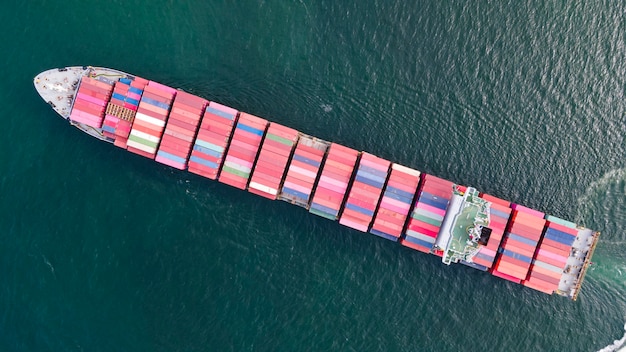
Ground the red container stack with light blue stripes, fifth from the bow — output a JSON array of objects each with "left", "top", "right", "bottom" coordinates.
[{"left": 188, "top": 102, "right": 239, "bottom": 180}]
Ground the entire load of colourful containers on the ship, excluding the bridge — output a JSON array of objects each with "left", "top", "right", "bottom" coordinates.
[{"left": 71, "top": 77, "right": 578, "bottom": 293}]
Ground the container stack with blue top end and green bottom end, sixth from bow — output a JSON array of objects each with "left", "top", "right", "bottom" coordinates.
[{"left": 219, "top": 112, "right": 267, "bottom": 190}]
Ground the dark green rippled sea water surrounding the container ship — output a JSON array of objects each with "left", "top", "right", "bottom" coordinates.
[{"left": 0, "top": 0, "right": 626, "bottom": 351}]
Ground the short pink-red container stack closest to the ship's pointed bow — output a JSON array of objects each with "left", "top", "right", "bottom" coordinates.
[{"left": 70, "top": 76, "right": 113, "bottom": 128}]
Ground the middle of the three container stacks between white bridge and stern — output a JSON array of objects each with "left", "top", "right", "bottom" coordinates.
[{"left": 492, "top": 204, "right": 546, "bottom": 284}]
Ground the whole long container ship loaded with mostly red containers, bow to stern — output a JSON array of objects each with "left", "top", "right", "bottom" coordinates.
[{"left": 34, "top": 66, "right": 600, "bottom": 300}]
